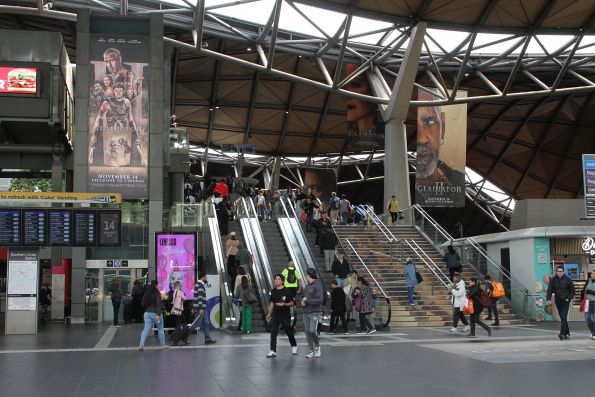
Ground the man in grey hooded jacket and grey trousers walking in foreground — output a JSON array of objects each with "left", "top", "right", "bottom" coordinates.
[{"left": 301, "top": 268, "right": 323, "bottom": 358}]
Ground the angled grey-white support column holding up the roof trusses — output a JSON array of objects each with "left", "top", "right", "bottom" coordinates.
[{"left": 382, "top": 22, "right": 427, "bottom": 208}]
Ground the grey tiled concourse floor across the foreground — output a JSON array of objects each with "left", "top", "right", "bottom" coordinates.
[{"left": 0, "top": 323, "right": 595, "bottom": 397}]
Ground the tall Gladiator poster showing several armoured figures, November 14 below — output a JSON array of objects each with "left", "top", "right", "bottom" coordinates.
[{"left": 88, "top": 34, "right": 149, "bottom": 199}]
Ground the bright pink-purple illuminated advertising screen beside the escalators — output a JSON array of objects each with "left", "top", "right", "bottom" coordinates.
[{"left": 155, "top": 233, "right": 197, "bottom": 299}]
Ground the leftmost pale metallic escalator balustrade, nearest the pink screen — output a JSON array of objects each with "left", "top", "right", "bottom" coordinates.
[{"left": 204, "top": 200, "right": 235, "bottom": 325}]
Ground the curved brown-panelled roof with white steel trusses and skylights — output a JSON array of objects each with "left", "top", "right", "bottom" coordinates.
[{"left": 0, "top": 0, "right": 595, "bottom": 229}]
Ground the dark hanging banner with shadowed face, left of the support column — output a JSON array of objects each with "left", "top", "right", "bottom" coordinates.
[{"left": 344, "top": 63, "right": 384, "bottom": 150}]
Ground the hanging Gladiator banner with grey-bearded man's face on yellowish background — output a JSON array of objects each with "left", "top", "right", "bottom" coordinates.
[{"left": 415, "top": 90, "right": 467, "bottom": 207}]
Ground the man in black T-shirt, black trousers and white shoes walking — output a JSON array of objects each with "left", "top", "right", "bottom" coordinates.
[{"left": 266, "top": 274, "right": 297, "bottom": 358}]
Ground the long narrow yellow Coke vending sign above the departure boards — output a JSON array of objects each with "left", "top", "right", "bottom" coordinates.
[{"left": 0, "top": 192, "right": 122, "bottom": 204}]
